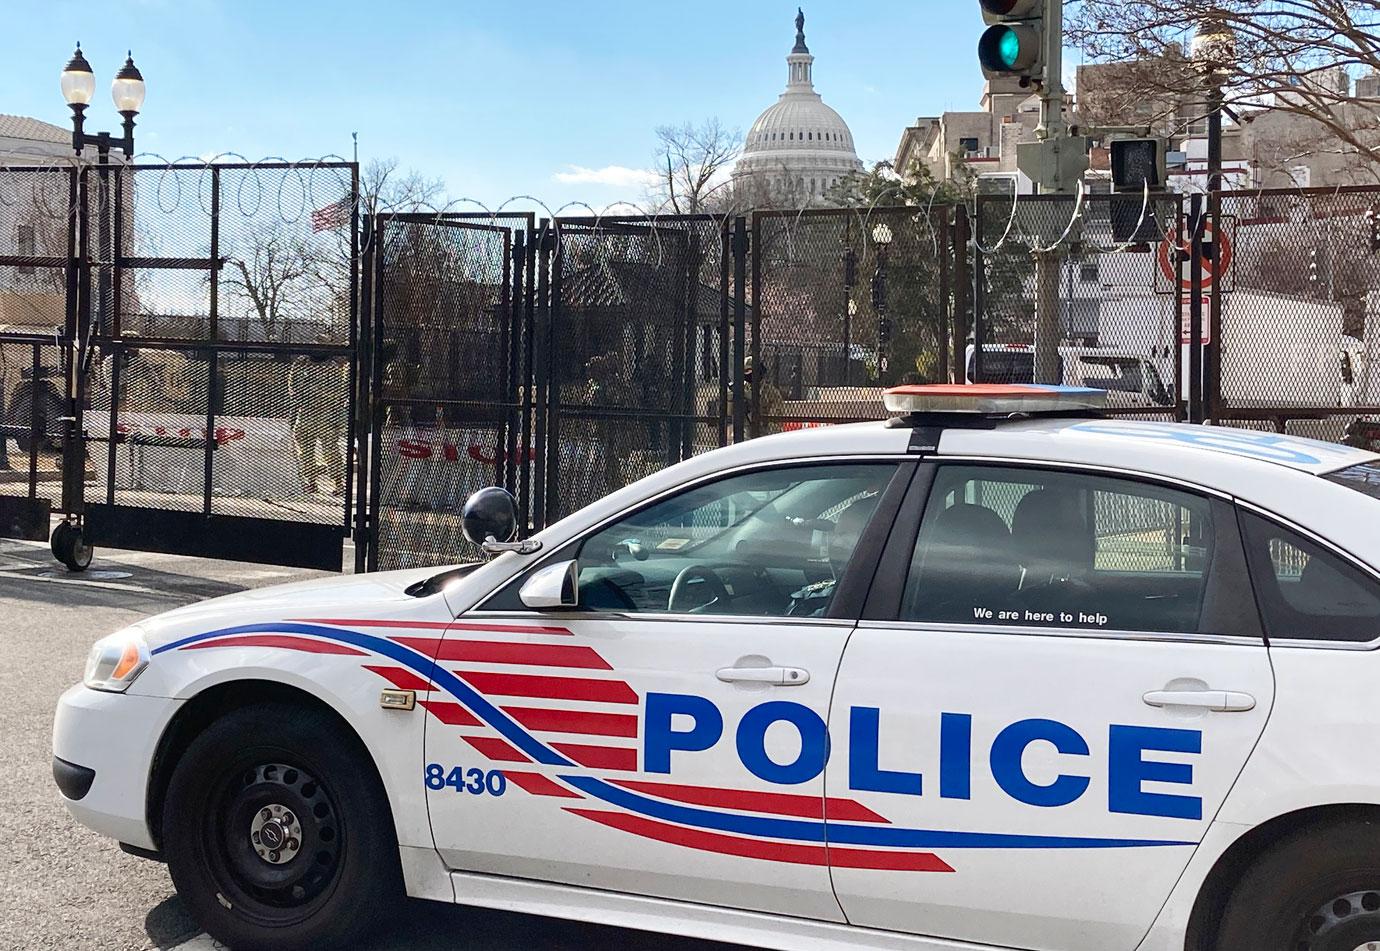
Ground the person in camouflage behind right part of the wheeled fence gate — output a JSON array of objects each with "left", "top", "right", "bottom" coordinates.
[{"left": 287, "top": 340, "right": 348, "bottom": 496}]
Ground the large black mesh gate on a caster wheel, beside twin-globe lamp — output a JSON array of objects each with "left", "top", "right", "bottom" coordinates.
[{"left": 76, "top": 163, "right": 359, "bottom": 571}]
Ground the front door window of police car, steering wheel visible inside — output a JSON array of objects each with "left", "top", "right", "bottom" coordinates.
[{"left": 577, "top": 464, "right": 896, "bottom": 617}]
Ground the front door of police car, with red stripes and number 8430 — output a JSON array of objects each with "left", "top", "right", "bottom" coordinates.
[{"left": 418, "top": 461, "right": 914, "bottom": 921}]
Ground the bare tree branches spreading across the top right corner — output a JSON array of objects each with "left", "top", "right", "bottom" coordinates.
[{"left": 1068, "top": 0, "right": 1380, "bottom": 173}]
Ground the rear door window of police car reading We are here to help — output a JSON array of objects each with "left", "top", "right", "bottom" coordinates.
[{"left": 901, "top": 467, "right": 1213, "bottom": 634}]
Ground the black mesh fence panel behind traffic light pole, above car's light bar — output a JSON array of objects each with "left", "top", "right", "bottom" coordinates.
[{"left": 963, "top": 195, "right": 1183, "bottom": 418}]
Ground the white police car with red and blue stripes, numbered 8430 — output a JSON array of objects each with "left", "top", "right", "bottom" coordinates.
[{"left": 54, "top": 386, "right": 1380, "bottom": 951}]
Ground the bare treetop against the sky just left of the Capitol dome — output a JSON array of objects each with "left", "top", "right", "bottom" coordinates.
[{"left": 650, "top": 119, "right": 742, "bottom": 214}]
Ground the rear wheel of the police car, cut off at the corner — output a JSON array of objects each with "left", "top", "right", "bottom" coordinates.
[{"left": 1212, "top": 820, "right": 1380, "bottom": 951}]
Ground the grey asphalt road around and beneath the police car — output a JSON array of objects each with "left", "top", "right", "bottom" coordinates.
[{"left": 0, "top": 540, "right": 729, "bottom": 951}]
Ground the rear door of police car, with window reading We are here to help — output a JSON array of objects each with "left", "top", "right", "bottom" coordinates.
[{"left": 825, "top": 464, "right": 1274, "bottom": 951}]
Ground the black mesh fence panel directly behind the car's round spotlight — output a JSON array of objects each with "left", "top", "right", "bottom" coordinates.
[{"left": 360, "top": 214, "right": 540, "bottom": 570}]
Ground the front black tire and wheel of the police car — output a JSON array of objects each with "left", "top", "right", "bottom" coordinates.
[{"left": 161, "top": 704, "right": 403, "bottom": 951}]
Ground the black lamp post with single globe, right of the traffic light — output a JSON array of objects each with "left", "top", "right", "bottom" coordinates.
[{"left": 1191, "top": 19, "right": 1236, "bottom": 418}]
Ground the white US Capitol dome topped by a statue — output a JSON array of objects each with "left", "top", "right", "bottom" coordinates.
[{"left": 733, "top": 11, "right": 863, "bottom": 204}]
